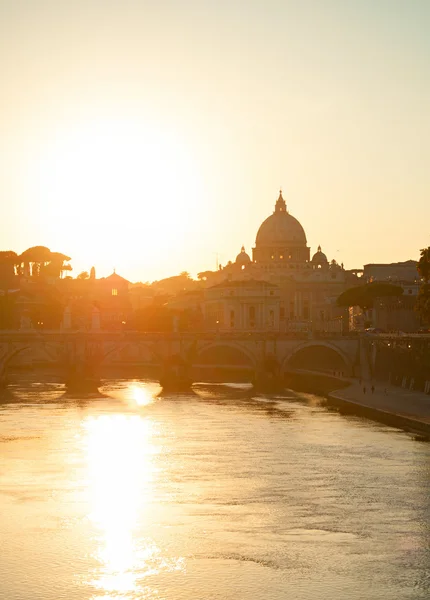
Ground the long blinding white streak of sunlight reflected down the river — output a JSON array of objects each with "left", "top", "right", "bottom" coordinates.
[{"left": 84, "top": 415, "right": 159, "bottom": 598}]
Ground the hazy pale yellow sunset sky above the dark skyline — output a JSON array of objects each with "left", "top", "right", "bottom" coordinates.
[{"left": 0, "top": 0, "right": 430, "bottom": 281}]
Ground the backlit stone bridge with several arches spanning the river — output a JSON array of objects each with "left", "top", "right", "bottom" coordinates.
[{"left": 0, "top": 331, "right": 360, "bottom": 390}]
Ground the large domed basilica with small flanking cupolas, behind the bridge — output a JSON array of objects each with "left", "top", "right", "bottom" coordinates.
[{"left": 201, "top": 191, "right": 362, "bottom": 333}]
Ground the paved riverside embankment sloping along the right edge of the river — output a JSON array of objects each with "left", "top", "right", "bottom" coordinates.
[{"left": 327, "top": 381, "right": 430, "bottom": 436}]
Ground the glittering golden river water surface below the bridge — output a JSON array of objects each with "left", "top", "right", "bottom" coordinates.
[{"left": 0, "top": 381, "right": 430, "bottom": 600}]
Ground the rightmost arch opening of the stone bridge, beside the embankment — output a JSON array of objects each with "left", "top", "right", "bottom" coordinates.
[{"left": 282, "top": 340, "right": 353, "bottom": 376}]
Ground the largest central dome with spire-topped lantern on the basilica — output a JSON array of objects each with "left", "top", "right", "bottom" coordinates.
[{"left": 255, "top": 192, "right": 306, "bottom": 246}]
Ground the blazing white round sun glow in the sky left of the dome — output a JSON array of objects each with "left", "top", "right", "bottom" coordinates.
[{"left": 28, "top": 120, "right": 202, "bottom": 274}]
